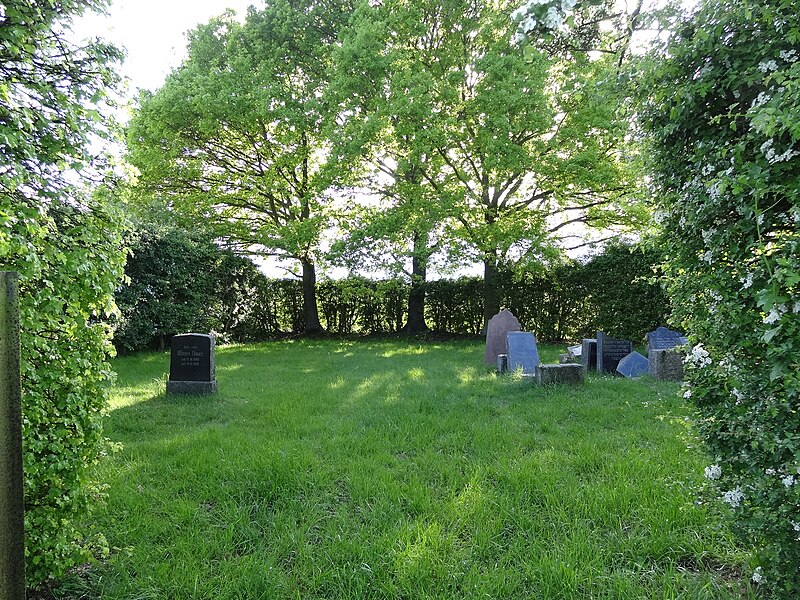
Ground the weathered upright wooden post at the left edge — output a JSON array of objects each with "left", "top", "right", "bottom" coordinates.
[{"left": 0, "top": 271, "right": 25, "bottom": 600}]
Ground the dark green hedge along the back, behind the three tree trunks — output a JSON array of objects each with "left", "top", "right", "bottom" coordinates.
[{"left": 115, "top": 237, "right": 669, "bottom": 351}]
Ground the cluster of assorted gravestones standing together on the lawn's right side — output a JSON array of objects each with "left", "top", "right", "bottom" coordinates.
[{"left": 484, "top": 309, "right": 687, "bottom": 384}]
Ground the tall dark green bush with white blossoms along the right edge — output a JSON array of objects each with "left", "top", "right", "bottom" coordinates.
[{"left": 642, "top": 0, "right": 800, "bottom": 598}]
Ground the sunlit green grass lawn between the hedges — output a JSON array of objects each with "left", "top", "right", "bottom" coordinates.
[{"left": 65, "top": 340, "right": 753, "bottom": 599}]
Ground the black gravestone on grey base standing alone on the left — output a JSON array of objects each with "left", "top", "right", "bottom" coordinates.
[{"left": 167, "top": 333, "right": 217, "bottom": 394}]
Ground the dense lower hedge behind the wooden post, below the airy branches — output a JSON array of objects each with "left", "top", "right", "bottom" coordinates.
[{"left": 0, "top": 196, "right": 124, "bottom": 586}]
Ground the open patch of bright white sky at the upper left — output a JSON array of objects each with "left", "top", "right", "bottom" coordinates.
[{"left": 73, "top": 0, "right": 261, "bottom": 96}]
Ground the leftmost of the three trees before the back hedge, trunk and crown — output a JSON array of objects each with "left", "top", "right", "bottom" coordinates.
[{"left": 127, "top": 0, "right": 350, "bottom": 332}]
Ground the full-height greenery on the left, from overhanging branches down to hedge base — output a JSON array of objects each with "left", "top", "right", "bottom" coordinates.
[{"left": 0, "top": 0, "right": 124, "bottom": 586}]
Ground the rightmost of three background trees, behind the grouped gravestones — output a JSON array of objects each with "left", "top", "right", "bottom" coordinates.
[{"left": 334, "top": 0, "right": 648, "bottom": 328}]
